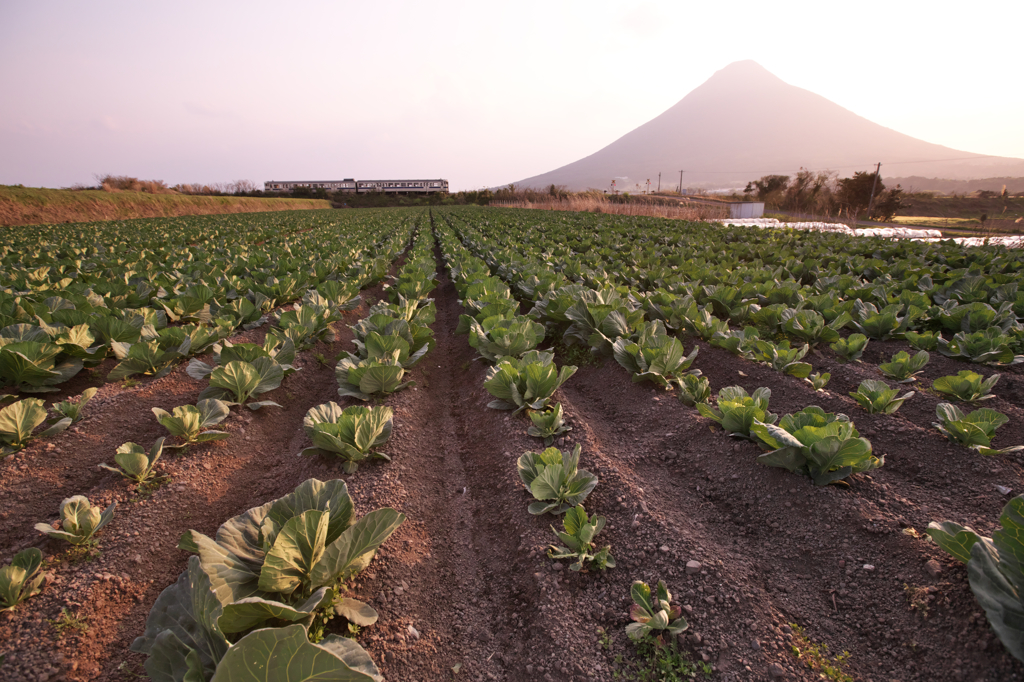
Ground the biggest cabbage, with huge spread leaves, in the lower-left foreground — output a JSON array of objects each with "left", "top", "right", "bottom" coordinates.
[{"left": 131, "top": 479, "right": 406, "bottom": 682}]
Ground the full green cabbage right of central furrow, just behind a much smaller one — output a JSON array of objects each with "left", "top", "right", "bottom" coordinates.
[{"left": 483, "top": 350, "right": 577, "bottom": 414}]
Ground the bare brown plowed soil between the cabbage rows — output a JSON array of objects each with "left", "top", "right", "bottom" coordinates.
[{"left": 0, "top": 241, "right": 1024, "bottom": 682}]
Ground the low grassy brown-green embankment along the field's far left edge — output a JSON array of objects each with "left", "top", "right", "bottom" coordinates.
[{"left": 0, "top": 185, "right": 331, "bottom": 226}]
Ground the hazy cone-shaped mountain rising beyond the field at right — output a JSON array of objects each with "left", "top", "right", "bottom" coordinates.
[{"left": 515, "top": 60, "right": 1024, "bottom": 190}]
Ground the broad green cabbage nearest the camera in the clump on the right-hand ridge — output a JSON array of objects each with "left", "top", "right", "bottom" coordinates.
[{"left": 751, "top": 406, "right": 885, "bottom": 485}]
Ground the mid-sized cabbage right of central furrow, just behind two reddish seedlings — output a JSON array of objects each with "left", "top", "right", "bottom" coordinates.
[{"left": 517, "top": 443, "right": 597, "bottom": 515}]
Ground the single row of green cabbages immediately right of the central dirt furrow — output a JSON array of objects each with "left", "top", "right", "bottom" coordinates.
[{"left": 438, "top": 210, "right": 710, "bottom": 659}]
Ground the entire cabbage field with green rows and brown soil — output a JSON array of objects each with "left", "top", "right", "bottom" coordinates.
[{"left": 0, "top": 207, "right": 1024, "bottom": 682}]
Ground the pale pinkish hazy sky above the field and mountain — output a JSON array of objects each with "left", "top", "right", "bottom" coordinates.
[{"left": 0, "top": 0, "right": 1024, "bottom": 190}]
